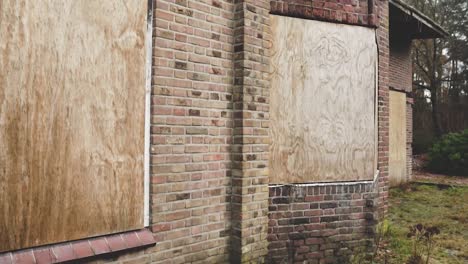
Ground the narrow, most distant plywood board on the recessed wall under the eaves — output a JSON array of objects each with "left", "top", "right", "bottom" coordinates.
[{"left": 388, "top": 91, "right": 407, "bottom": 185}]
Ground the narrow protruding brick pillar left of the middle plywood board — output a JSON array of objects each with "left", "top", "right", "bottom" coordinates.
[{"left": 231, "top": 0, "right": 271, "bottom": 263}]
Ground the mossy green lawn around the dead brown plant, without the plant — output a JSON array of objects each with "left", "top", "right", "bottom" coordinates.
[{"left": 388, "top": 183, "right": 468, "bottom": 264}]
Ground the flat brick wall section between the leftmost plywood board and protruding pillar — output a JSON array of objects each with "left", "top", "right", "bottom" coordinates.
[{"left": 148, "top": 0, "right": 234, "bottom": 263}]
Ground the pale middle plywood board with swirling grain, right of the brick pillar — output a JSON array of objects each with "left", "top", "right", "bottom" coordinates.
[{"left": 269, "top": 16, "right": 377, "bottom": 183}]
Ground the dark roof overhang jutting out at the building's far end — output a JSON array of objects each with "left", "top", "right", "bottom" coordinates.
[{"left": 389, "top": 0, "right": 449, "bottom": 39}]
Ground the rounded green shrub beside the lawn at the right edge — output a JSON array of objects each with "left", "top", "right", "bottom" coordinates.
[{"left": 428, "top": 129, "right": 468, "bottom": 176}]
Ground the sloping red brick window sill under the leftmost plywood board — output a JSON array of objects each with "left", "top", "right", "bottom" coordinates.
[{"left": 0, "top": 228, "right": 156, "bottom": 264}]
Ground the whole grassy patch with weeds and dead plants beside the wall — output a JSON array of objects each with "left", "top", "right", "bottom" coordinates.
[{"left": 350, "top": 183, "right": 468, "bottom": 264}]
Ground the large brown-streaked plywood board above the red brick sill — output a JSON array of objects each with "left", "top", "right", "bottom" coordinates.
[{"left": 0, "top": 0, "right": 147, "bottom": 251}]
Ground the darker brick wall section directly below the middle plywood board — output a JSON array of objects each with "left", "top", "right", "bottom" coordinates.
[{"left": 268, "top": 182, "right": 378, "bottom": 264}]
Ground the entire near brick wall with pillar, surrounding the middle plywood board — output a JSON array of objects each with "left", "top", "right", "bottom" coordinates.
[{"left": 76, "top": 0, "right": 389, "bottom": 263}]
